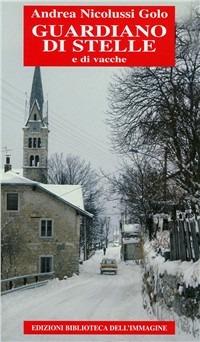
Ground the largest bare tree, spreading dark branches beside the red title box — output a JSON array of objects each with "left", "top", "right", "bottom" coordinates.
[{"left": 108, "top": 13, "right": 200, "bottom": 195}]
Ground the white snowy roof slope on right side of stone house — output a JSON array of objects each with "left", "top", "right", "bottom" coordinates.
[{"left": 40, "top": 183, "right": 84, "bottom": 210}]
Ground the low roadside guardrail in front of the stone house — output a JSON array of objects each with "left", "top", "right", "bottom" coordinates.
[{"left": 1, "top": 272, "right": 54, "bottom": 295}]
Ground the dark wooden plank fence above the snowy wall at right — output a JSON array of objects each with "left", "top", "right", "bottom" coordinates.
[{"left": 170, "top": 218, "right": 200, "bottom": 261}]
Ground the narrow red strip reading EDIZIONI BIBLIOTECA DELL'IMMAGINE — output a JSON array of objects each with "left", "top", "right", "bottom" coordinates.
[{"left": 24, "top": 321, "right": 175, "bottom": 335}]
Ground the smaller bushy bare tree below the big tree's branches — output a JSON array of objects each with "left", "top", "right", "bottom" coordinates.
[{"left": 107, "top": 156, "right": 183, "bottom": 230}]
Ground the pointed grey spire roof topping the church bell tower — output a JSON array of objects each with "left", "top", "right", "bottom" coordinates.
[{"left": 30, "top": 67, "right": 44, "bottom": 114}]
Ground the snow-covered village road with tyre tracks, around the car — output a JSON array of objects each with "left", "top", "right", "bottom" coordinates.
[{"left": 1, "top": 247, "right": 198, "bottom": 342}]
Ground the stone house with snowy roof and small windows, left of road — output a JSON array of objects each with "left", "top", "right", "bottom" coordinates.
[{"left": 1, "top": 171, "right": 92, "bottom": 279}]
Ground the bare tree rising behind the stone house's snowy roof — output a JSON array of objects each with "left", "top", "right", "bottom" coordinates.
[{"left": 48, "top": 153, "right": 103, "bottom": 249}]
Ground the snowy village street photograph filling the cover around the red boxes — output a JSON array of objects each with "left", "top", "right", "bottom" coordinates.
[{"left": 1, "top": 0, "right": 200, "bottom": 342}]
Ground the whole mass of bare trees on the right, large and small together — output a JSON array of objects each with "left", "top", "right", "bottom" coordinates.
[{"left": 107, "top": 9, "right": 200, "bottom": 223}]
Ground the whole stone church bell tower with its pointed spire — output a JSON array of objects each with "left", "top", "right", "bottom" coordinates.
[{"left": 23, "top": 67, "right": 49, "bottom": 183}]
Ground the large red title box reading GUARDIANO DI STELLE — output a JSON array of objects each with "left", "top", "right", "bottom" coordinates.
[{"left": 24, "top": 6, "right": 175, "bottom": 67}]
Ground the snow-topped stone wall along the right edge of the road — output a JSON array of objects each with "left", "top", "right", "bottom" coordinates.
[{"left": 143, "top": 242, "right": 200, "bottom": 340}]
